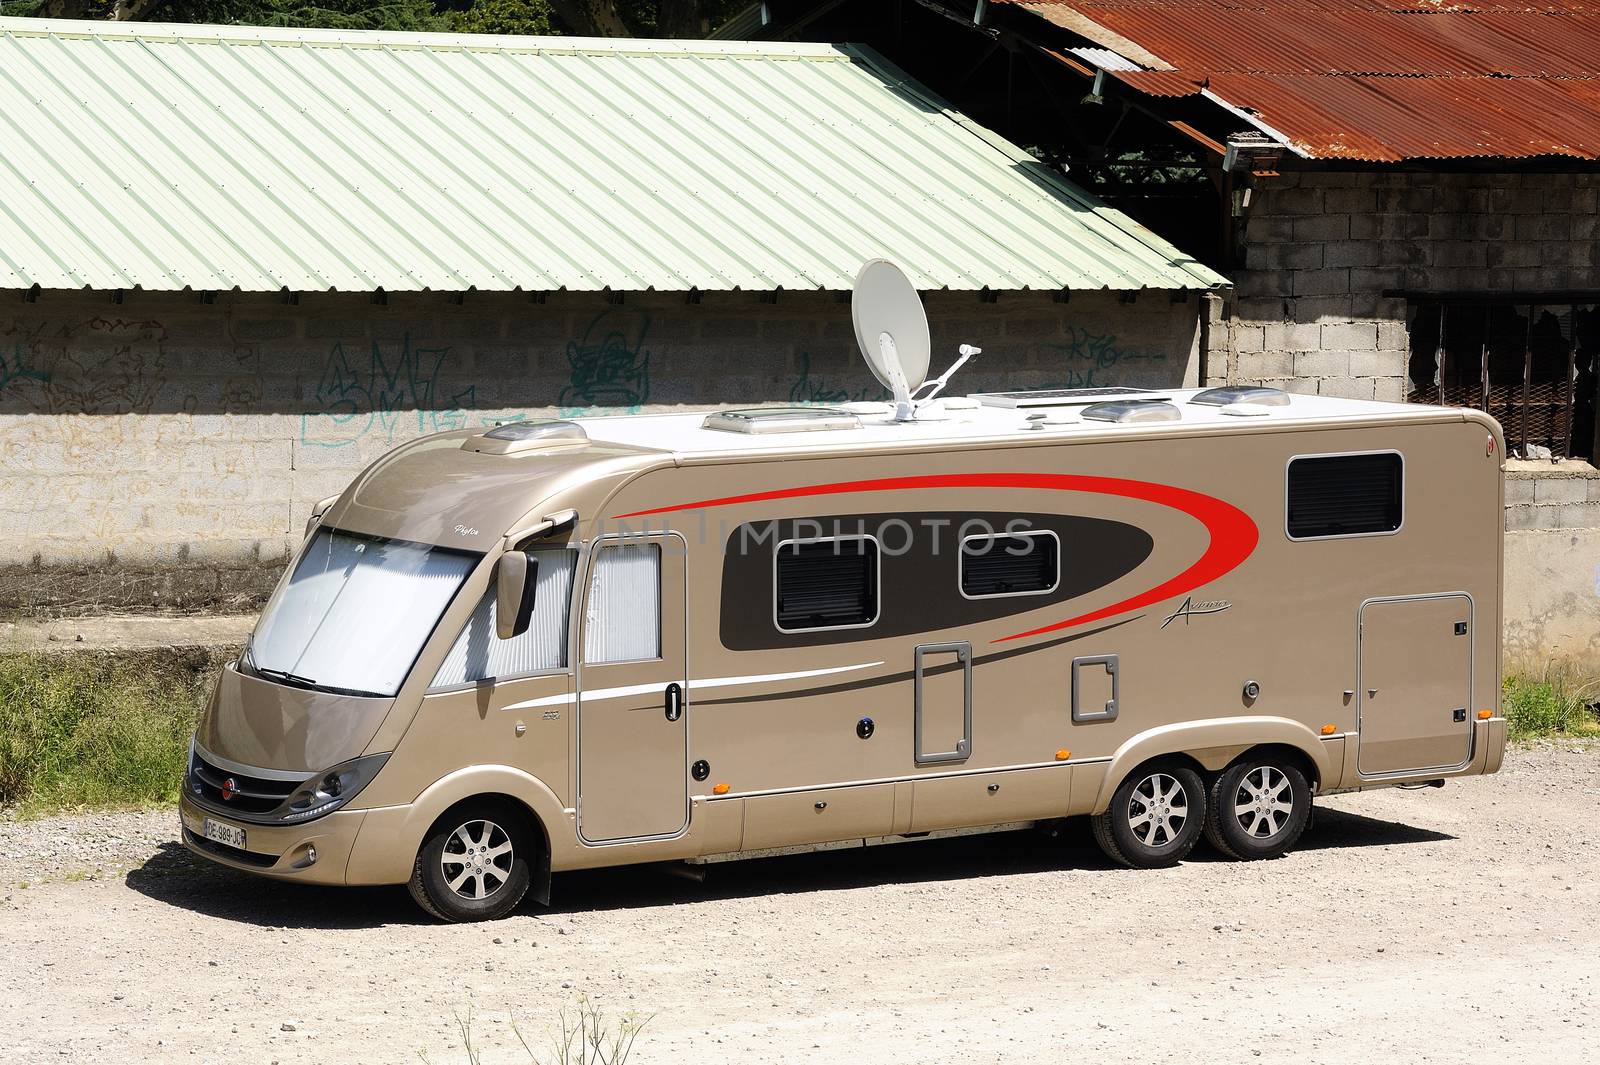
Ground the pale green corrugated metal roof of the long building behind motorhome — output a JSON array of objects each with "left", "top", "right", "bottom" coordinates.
[{"left": 0, "top": 19, "right": 1226, "bottom": 291}]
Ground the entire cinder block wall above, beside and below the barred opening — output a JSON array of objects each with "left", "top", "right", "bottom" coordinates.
[{"left": 1205, "top": 173, "right": 1600, "bottom": 667}]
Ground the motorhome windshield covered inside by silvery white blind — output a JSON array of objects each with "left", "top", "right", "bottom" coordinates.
[{"left": 243, "top": 529, "right": 480, "bottom": 696}]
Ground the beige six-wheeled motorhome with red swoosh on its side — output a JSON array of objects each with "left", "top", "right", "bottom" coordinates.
[{"left": 179, "top": 260, "right": 1506, "bottom": 919}]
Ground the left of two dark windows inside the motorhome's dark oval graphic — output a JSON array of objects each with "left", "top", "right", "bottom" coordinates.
[{"left": 773, "top": 536, "right": 878, "bottom": 632}]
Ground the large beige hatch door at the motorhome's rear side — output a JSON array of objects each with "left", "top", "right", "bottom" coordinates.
[{"left": 1355, "top": 595, "right": 1474, "bottom": 777}]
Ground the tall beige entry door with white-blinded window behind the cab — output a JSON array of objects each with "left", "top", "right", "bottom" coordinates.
[{"left": 578, "top": 536, "right": 690, "bottom": 843}]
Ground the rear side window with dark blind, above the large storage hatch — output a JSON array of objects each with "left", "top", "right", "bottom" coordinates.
[{"left": 1285, "top": 451, "right": 1405, "bottom": 540}]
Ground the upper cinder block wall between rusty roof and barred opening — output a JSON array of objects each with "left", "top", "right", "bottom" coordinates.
[{"left": 1206, "top": 171, "right": 1600, "bottom": 400}]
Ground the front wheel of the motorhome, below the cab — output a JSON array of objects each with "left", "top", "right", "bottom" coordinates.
[{"left": 406, "top": 801, "right": 538, "bottom": 921}]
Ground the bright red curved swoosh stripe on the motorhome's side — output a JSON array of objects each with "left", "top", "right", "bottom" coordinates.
[{"left": 613, "top": 473, "right": 1261, "bottom": 643}]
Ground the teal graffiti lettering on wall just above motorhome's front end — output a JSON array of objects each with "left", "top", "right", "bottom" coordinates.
[{"left": 301, "top": 333, "right": 477, "bottom": 448}]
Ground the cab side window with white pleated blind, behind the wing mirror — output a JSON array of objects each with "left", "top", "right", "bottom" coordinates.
[{"left": 430, "top": 548, "right": 578, "bottom": 688}]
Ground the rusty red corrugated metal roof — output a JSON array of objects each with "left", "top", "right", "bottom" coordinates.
[{"left": 997, "top": 0, "right": 1600, "bottom": 162}]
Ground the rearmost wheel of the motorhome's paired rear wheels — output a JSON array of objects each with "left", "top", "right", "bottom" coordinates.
[{"left": 1205, "top": 758, "right": 1310, "bottom": 860}]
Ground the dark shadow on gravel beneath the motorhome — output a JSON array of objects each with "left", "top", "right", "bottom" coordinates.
[{"left": 126, "top": 809, "right": 1454, "bottom": 929}]
